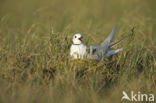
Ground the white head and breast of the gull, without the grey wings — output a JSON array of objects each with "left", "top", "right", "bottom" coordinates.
[{"left": 70, "top": 34, "right": 86, "bottom": 59}]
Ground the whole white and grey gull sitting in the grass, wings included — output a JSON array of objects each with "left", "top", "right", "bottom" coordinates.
[{"left": 70, "top": 25, "right": 128, "bottom": 60}]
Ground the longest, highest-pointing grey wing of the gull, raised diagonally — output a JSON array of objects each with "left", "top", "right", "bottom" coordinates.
[{"left": 101, "top": 24, "right": 118, "bottom": 53}]
